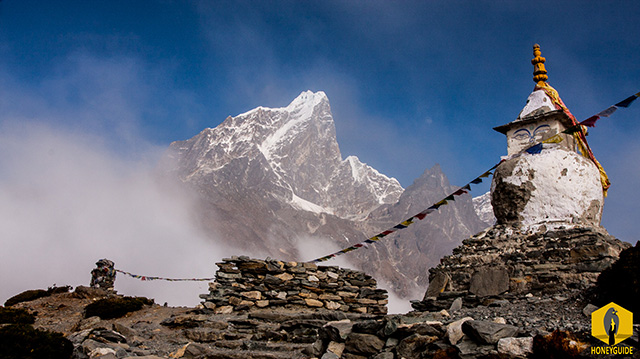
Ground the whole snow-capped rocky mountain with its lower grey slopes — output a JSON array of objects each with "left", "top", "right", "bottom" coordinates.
[{"left": 164, "top": 91, "right": 484, "bottom": 296}]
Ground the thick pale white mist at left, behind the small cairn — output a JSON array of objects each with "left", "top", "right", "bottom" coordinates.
[{"left": 0, "top": 121, "right": 230, "bottom": 306}]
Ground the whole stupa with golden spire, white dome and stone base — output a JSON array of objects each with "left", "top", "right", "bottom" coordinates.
[{"left": 413, "top": 45, "right": 630, "bottom": 310}]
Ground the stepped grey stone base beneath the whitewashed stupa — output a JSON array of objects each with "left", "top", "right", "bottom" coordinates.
[{"left": 412, "top": 225, "right": 629, "bottom": 310}]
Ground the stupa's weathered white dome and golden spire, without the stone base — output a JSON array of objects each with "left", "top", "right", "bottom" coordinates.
[{"left": 491, "top": 45, "right": 608, "bottom": 228}]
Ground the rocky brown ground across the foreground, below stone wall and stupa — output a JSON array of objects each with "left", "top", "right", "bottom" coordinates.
[{"left": 0, "top": 287, "right": 639, "bottom": 359}]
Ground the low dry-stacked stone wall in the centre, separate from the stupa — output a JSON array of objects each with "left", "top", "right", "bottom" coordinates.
[{"left": 200, "top": 256, "right": 388, "bottom": 314}]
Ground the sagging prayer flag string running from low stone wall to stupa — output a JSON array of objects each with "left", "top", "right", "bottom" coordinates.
[{"left": 310, "top": 163, "right": 500, "bottom": 263}]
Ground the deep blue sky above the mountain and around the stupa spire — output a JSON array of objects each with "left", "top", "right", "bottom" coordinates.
[{"left": 0, "top": 0, "right": 640, "bottom": 246}]
